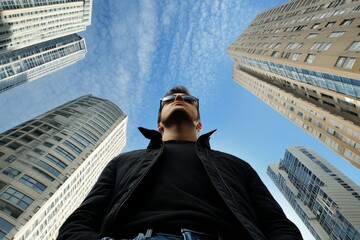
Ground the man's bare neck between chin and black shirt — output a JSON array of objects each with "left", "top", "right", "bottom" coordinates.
[{"left": 162, "top": 125, "right": 197, "bottom": 142}]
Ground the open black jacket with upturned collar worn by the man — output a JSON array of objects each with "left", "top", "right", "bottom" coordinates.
[{"left": 58, "top": 128, "right": 302, "bottom": 240}]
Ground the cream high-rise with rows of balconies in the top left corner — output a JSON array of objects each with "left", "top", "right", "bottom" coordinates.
[{"left": 0, "top": 0, "right": 92, "bottom": 53}]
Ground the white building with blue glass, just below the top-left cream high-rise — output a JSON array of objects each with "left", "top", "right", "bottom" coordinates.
[{"left": 0, "top": 34, "right": 87, "bottom": 93}]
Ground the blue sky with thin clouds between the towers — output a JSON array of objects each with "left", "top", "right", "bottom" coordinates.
[{"left": 0, "top": 0, "right": 360, "bottom": 239}]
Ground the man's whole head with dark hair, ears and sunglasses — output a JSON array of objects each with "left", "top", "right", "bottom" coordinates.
[{"left": 158, "top": 86, "right": 201, "bottom": 132}]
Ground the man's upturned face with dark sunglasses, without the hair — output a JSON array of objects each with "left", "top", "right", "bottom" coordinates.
[{"left": 160, "top": 93, "right": 199, "bottom": 127}]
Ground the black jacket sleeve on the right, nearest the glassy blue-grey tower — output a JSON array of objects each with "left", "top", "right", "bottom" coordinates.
[{"left": 247, "top": 166, "right": 303, "bottom": 240}]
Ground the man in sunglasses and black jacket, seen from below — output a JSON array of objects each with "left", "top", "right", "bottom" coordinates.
[{"left": 58, "top": 86, "right": 302, "bottom": 240}]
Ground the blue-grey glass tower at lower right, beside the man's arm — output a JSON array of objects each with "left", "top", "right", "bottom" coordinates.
[{"left": 267, "top": 147, "right": 360, "bottom": 240}]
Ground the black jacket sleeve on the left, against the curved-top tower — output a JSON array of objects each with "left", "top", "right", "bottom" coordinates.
[{"left": 57, "top": 160, "right": 116, "bottom": 240}]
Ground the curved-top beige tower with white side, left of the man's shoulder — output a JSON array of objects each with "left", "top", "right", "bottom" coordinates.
[{"left": 0, "top": 95, "right": 127, "bottom": 240}]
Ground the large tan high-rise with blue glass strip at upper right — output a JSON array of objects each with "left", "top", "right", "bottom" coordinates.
[{"left": 227, "top": 0, "right": 360, "bottom": 168}]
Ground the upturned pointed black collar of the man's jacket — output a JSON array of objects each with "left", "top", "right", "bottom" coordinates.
[{"left": 139, "top": 127, "right": 216, "bottom": 149}]
